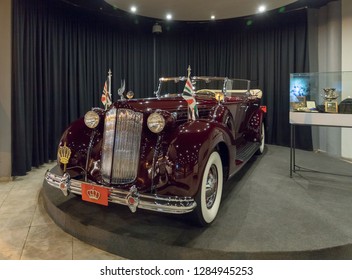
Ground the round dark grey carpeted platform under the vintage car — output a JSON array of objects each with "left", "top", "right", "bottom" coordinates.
[{"left": 41, "top": 146, "right": 352, "bottom": 260}]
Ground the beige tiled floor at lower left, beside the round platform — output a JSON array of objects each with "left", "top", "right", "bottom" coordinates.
[{"left": 0, "top": 164, "right": 123, "bottom": 260}]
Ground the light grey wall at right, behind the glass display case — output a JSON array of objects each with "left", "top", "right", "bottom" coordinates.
[{"left": 309, "top": 0, "right": 352, "bottom": 159}]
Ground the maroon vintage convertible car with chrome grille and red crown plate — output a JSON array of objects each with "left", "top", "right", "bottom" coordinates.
[{"left": 44, "top": 72, "right": 265, "bottom": 225}]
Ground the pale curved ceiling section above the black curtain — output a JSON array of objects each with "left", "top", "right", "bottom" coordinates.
[{"left": 104, "top": 0, "right": 296, "bottom": 21}]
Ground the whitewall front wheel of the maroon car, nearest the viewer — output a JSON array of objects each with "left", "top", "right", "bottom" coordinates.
[{"left": 194, "top": 151, "right": 223, "bottom": 226}]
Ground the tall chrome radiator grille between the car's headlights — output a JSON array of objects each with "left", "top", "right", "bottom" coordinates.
[{"left": 101, "top": 108, "right": 143, "bottom": 184}]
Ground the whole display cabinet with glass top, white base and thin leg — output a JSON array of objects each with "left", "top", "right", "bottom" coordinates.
[{"left": 289, "top": 71, "right": 352, "bottom": 177}]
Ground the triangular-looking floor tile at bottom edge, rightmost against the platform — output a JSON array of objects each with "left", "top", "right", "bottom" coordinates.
[{"left": 73, "top": 238, "right": 124, "bottom": 260}]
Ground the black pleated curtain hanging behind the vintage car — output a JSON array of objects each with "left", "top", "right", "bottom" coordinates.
[{"left": 12, "top": 0, "right": 312, "bottom": 176}]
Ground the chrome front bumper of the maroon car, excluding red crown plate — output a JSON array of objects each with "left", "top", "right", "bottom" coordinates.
[{"left": 44, "top": 170, "right": 197, "bottom": 214}]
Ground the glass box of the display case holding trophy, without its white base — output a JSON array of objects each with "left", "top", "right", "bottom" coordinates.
[{"left": 290, "top": 72, "right": 352, "bottom": 114}]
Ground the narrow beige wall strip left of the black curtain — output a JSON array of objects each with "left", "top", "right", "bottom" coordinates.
[{"left": 0, "top": 0, "right": 11, "bottom": 181}]
